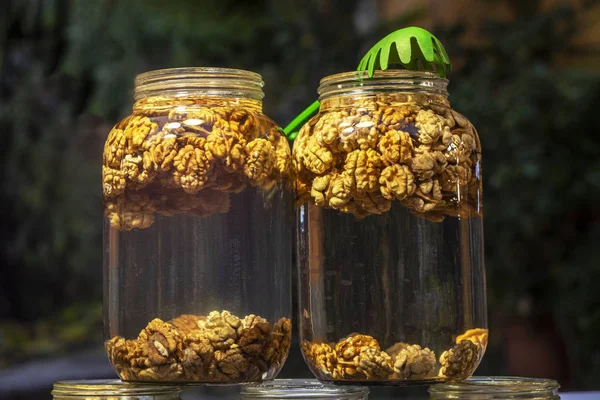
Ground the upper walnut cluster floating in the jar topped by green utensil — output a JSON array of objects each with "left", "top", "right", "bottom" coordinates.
[{"left": 292, "top": 94, "right": 481, "bottom": 221}]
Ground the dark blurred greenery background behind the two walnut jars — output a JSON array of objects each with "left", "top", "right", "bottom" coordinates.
[{"left": 0, "top": 0, "right": 600, "bottom": 399}]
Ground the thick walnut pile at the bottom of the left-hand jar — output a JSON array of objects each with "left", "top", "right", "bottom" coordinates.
[{"left": 106, "top": 311, "right": 292, "bottom": 383}]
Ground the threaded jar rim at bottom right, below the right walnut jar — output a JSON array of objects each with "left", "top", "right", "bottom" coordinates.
[{"left": 429, "top": 376, "right": 560, "bottom": 395}]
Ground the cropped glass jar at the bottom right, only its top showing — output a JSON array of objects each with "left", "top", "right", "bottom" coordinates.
[{"left": 429, "top": 376, "right": 560, "bottom": 400}]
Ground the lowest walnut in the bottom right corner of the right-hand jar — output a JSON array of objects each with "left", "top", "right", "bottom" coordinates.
[{"left": 439, "top": 340, "right": 479, "bottom": 381}]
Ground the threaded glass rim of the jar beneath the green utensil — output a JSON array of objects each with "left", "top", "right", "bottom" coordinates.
[{"left": 317, "top": 69, "right": 449, "bottom": 100}]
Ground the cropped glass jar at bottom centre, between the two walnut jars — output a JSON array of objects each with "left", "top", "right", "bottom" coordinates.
[{"left": 241, "top": 379, "right": 369, "bottom": 400}]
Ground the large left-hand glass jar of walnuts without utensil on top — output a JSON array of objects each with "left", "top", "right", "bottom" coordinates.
[{"left": 102, "top": 68, "right": 293, "bottom": 384}]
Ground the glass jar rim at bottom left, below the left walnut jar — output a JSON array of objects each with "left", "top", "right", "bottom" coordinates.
[{"left": 52, "top": 379, "right": 183, "bottom": 396}]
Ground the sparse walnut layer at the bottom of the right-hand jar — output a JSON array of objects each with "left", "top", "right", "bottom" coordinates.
[{"left": 302, "top": 329, "right": 487, "bottom": 381}]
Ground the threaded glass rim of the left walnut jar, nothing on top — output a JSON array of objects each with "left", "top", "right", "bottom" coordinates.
[{"left": 134, "top": 67, "right": 264, "bottom": 101}]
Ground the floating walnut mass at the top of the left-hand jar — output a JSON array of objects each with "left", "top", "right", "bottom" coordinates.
[{"left": 102, "top": 98, "right": 291, "bottom": 230}]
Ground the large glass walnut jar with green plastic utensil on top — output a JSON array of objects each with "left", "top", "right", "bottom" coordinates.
[{"left": 292, "top": 70, "right": 488, "bottom": 385}]
